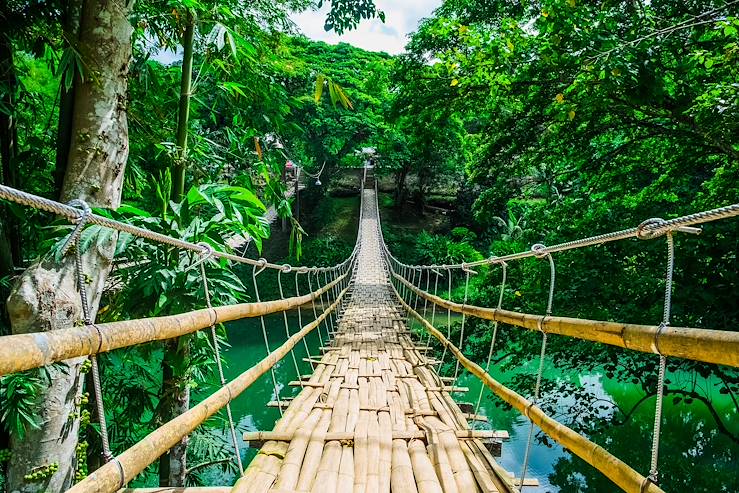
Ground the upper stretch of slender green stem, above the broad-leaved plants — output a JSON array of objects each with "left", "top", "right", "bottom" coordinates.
[{"left": 172, "top": 9, "right": 195, "bottom": 202}]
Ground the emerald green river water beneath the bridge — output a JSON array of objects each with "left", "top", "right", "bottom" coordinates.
[{"left": 224, "top": 311, "right": 739, "bottom": 493}]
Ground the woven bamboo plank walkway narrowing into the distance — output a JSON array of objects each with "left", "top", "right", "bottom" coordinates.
[{"left": 234, "top": 189, "right": 515, "bottom": 493}]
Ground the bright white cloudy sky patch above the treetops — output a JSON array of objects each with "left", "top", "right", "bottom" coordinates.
[{"left": 292, "top": 0, "right": 441, "bottom": 55}]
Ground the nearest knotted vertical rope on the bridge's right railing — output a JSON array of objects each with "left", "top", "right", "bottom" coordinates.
[{"left": 637, "top": 218, "right": 680, "bottom": 489}]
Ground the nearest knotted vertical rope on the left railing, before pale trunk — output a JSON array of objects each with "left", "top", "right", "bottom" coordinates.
[{"left": 67, "top": 199, "right": 113, "bottom": 462}]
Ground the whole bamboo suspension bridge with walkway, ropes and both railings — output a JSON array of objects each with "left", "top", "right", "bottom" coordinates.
[{"left": 0, "top": 171, "right": 739, "bottom": 493}]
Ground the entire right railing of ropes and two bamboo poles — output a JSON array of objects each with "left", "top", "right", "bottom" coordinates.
[{"left": 378, "top": 180, "right": 739, "bottom": 493}]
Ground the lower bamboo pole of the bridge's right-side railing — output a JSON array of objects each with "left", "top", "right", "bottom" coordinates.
[{"left": 391, "top": 284, "right": 664, "bottom": 493}]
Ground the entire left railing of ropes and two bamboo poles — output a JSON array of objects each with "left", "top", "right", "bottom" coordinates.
[{"left": 0, "top": 175, "right": 361, "bottom": 491}]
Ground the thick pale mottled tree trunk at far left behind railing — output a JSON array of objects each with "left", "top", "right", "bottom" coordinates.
[{"left": 8, "top": 0, "right": 132, "bottom": 493}]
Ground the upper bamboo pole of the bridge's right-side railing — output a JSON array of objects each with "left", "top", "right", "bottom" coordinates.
[{"left": 392, "top": 272, "right": 739, "bottom": 367}]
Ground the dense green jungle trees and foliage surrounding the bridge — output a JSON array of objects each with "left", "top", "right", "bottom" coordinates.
[{"left": 0, "top": 0, "right": 739, "bottom": 492}]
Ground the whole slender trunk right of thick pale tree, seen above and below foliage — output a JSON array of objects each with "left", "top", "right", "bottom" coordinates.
[{"left": 159, "top": 9, "right": 195, "bottom": 487}]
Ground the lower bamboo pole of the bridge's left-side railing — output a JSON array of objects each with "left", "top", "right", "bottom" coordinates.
[{"left": 68, "top": 288, "right": 348, "bottom": 493}]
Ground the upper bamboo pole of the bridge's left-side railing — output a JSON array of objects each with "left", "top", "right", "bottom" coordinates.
[{"left": 0, "top": 272, "right": 349, "bottom": 376}]
